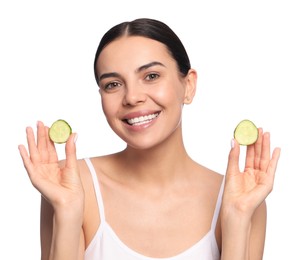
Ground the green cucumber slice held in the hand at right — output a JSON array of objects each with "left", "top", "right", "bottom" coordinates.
[{"left": 234, "top": 119, "right": 259, "bottom": 145}]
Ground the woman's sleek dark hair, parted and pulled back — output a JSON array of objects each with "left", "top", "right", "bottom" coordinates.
[{"left": 94, "top": 18, "right": 191, "bottom": 82}]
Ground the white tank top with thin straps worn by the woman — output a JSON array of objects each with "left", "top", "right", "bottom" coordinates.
[{"left": 84, "top": 158, "right": 224, "bottom": 260}]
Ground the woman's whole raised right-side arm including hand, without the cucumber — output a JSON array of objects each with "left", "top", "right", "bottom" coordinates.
[{"left": 221, "top": 129, "right": 280, "bottom": 260}]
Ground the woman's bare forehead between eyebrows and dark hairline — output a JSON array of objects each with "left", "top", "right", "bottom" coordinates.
[{"left": 97, "top": 36, "right": 174, "bottom": 71}]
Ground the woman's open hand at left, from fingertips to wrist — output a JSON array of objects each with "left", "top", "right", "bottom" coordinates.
[{"left": 19, "top": 122, "right": 84, "bottom": 211}]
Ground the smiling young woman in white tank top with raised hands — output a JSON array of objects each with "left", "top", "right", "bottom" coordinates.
[{"left": 19, "top": 19, "right": 280, "bottom": 260}]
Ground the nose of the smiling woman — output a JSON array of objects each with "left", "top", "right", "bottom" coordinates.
[{"left": 123, "top": 84, "right": 146, "bottom": 106}]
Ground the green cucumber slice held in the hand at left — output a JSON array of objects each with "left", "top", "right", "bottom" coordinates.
[{"left": 49, "top": 119, "right": 72, "bottom": 144}]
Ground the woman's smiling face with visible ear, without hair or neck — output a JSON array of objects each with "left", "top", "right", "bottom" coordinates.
[{"left": 96, "top": 36, "right": 196, "bottom": 149}]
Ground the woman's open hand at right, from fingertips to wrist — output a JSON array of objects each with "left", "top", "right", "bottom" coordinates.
[{"left": 223, "top": 128, "right": 280, "bottom": 217}]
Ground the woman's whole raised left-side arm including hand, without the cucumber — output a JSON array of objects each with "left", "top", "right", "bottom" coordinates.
[{"left": 19, "top": 122, "right": 84, "bottom": 260}]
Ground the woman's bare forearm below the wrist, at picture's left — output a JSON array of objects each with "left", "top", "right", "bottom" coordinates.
[{"left": 49, "top": 206, "right": 82, "bottom": 260}]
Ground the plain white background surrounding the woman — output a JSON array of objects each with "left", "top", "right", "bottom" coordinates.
[{"left": 0, "top": 0, "right": 299, "bottom": 260}]
